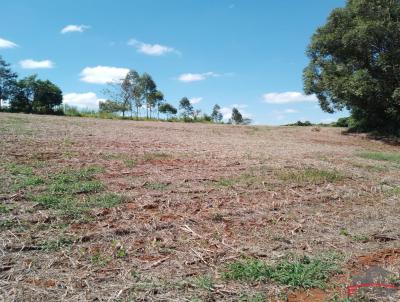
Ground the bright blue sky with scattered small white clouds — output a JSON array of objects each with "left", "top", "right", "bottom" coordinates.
[{"left": 0, "top": 0, "right": 347, "bottom": 125}]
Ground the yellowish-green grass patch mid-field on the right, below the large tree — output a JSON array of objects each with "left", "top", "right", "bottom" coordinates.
[{"left": 278, "top": 168, "right": 344, "bottom": 184}]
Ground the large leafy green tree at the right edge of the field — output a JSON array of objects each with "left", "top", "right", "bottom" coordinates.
[{"left": 304, "top": 0, "right": 400, "bottom": 134}]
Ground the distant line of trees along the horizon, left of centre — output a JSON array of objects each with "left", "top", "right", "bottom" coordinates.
[{"left": 0, "top": 56, "right": 251, "bottom": 124}]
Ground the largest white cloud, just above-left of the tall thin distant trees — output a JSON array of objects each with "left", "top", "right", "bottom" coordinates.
[{"left": 80, "top": 66, "right": 129, "bottom": 84}]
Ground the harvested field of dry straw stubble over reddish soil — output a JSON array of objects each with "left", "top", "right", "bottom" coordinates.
[{"left": 0, "top": 113, "right": 400, "bottom": 302}]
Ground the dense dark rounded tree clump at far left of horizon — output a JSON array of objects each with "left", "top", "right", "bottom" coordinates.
[{"left": 10, "top": 75, "right": 63, "bottom": 114}]
